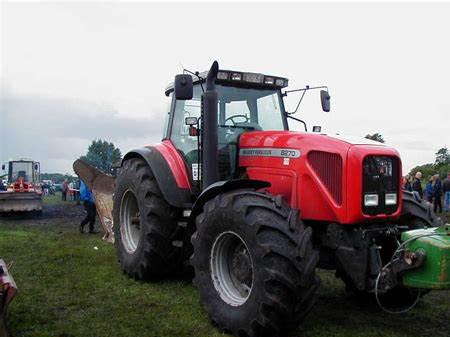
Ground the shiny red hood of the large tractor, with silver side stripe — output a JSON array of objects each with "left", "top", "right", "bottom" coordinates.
[{"left": 239, "top": 131, "right": 401, "bottom": 224}]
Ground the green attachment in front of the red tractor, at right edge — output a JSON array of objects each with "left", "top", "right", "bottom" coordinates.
[{"left": 401, "top": 224, "right": 450, "bottom": 289}]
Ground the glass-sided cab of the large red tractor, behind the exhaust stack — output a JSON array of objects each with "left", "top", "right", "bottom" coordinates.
[{"left": 165, "top": 70, "right": 288, "bottom": 183}]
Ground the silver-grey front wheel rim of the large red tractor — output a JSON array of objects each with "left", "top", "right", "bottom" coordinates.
[{"left": 211, "top": 231, "right": 254, "bottom": 306}]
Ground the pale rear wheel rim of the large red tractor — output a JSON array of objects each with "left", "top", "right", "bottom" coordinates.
[{"left": 120, "top": 190, "right": 141, "bottom": 254}]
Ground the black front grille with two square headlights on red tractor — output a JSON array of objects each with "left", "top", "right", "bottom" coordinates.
[{"left": 362, "top": 156, "right": 400, "bottom": 215}]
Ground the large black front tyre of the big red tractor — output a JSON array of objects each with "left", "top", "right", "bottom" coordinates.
[{"left": 191, "top": 190, "right": 320, "bottom": 337}]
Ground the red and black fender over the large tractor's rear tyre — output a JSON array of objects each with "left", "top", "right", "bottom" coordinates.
[{"left": 122, "top": 141, "right": 192, "bottom": 208}]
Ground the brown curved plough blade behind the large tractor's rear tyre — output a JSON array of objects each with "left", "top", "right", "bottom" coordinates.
[{"left": 73, "top": 159, "right": 115, "bottom": 243}]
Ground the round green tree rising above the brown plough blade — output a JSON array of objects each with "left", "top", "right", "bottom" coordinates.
[{"left": 80, "top": 139, "right": 122, "bottom": 174}]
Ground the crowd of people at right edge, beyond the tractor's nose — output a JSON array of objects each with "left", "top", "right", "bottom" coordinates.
[{"left": 403, "top": 172, "right": 450, "bottom": 213}]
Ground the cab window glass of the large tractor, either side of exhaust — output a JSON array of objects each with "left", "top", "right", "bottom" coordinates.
[{"left": 170, "top": 84, "right": 287, "bottom": 180}]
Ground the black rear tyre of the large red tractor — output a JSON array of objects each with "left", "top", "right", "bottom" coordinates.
[{"left": 113, "top": 158, "right": 182, "bottom": 280}]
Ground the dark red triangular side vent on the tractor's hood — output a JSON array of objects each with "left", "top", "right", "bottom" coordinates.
[{"left": 308, "top": 151, "right": 342, "bottom": 205}]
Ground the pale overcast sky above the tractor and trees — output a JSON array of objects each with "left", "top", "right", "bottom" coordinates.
[{"left": 0, "top": 1, "right": 450, "bottom": 172}]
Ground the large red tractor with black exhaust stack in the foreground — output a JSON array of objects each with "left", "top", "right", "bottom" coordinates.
[{"left": 76, "top": 62, "right": 439, "bottom": 336}]
